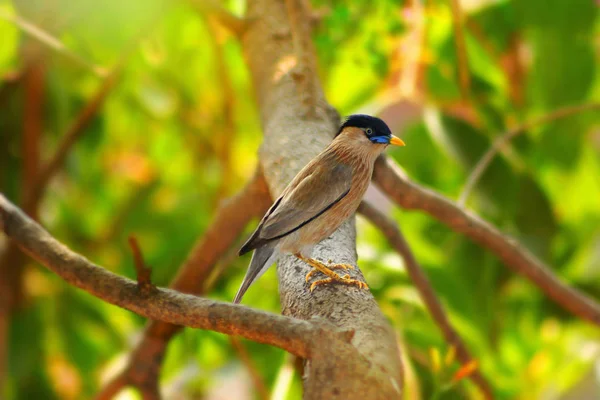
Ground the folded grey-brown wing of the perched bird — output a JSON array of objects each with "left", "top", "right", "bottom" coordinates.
[{"left": 240, "top": 153, "right": 352, "bottom": 253}]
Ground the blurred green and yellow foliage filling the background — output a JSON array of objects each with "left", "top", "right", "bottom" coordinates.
[{"left": 0, "top": 0, "right": 600, "bottom": 399}]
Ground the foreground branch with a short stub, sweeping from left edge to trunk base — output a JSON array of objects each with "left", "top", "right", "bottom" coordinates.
[{"left": 0, "top": 195, "right": 390, "bottom": 399}]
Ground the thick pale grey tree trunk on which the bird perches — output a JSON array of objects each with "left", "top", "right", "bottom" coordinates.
[{"left": 243, "top": 0, "right": 402, "bottom": 399}]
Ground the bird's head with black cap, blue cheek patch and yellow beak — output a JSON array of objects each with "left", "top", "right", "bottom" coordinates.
[{"left": 336, "top": 114, "right": 405, "bottom": 152}]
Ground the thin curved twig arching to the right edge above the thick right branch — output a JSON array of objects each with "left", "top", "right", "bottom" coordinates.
[{"left": 458, "top": 103, "right": 600, "bottom": 207}]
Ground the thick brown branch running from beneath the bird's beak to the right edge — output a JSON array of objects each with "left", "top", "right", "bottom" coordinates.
[{"left": 373, "top": 157, "right": 600, "bottom": 325}]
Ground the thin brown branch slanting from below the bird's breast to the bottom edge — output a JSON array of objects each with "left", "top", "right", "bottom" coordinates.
[{"left": 358, "top": 201, "right": 494, "bottom": 399}]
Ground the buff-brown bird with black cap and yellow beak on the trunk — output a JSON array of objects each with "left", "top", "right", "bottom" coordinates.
[{"left": 233, "top": 114, "right": 405, "bottom": 303}]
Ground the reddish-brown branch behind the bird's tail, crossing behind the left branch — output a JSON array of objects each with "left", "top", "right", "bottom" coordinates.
[{"left": 97, "top": 169, "right": 271, "bottom": 399}]
